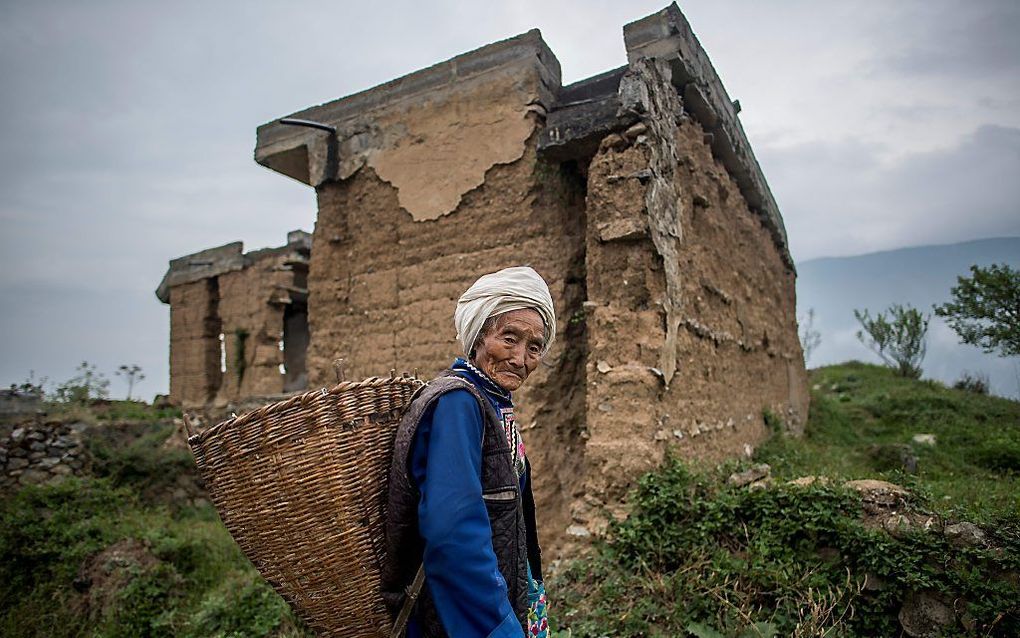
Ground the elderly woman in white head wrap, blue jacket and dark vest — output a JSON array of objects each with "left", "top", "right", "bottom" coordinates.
[{"left": 383, "top": 267, "right": 556, "bottom": 638}]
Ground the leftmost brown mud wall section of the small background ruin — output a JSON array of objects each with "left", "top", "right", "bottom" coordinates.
[{"left": 169, "top": 277, "right": 222, "bottom": 407}]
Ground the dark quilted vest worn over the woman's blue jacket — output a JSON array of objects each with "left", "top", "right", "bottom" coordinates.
[{"left": 381, "top": 371, "right": 541, "bottom": 638}]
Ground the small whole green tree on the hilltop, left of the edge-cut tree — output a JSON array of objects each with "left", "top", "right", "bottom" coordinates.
[{"left": 854, "top": 303, "right": 931, "bottom": 379}]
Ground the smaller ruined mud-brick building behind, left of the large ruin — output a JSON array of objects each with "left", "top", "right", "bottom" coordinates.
[{"left": 156, "top": 231, "right": 311, "bottom": 408}]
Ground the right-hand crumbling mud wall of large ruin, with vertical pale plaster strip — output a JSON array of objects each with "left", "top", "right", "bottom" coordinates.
[{"left": 572, "top": 58, "right": 808, "bottom": 536}]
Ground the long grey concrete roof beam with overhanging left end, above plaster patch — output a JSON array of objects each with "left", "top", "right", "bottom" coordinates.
[{"left": 255, "top": 29, "right": 560, "bottom": 187}]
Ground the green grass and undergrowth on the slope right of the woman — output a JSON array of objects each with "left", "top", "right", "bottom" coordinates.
[{"left": 549, "top": 362, "right": 1020, "bottom": 638}]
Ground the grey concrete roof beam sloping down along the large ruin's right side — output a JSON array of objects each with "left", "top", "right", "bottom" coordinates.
[{"left": 623, "top": 2, "right": 794, "bottom": 268}]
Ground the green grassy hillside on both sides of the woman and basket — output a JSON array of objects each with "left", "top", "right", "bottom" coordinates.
[{"left": 0, "top": 362, "right": 1020, "bottom": 638}]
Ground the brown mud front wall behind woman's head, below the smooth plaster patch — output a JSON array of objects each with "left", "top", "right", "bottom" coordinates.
[{"left": 308, "top": 138, "right": 585, "bottom": 551}]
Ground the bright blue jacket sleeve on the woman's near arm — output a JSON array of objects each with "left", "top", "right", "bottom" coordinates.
[{"left": 411, "top": 390, "right": 524, "bottom": 638}]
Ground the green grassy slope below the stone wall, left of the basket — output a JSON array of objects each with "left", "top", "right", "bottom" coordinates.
[{"left": 0, "top": 479, "right": 311, "bottom": 638}]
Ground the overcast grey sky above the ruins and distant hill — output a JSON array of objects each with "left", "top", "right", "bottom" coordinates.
[{"left": 0, "top": 0, "right": 1020, "bottom": 398}]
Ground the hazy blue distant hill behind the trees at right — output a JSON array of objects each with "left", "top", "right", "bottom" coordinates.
[{"left": 797, "top": 237, "right": 1020, "bottom": 397}]
